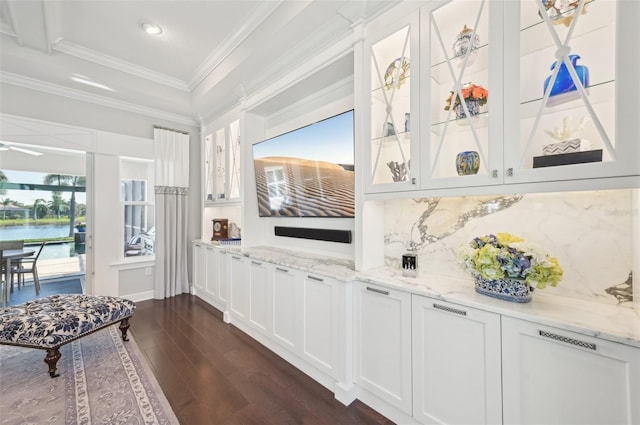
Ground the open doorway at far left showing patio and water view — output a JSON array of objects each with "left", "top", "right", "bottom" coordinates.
[{"left": 0, "top": 142, "right": 90, "bottom": 305}]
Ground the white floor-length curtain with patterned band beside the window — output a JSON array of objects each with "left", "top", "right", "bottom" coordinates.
[{"left": 154, "top": 128, "right": 189, "bottom": 299}]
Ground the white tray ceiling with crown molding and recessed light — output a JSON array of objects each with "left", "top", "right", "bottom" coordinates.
[{"left": 0, "top": 0, "right": 397, "bottom": 122}]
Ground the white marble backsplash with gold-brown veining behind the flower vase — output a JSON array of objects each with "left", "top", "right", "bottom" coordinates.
[{"left": 385, "top": 189, "right": 640, "bottom": 307}]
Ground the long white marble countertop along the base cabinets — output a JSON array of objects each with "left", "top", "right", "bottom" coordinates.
[{"left": 196, "top": 241, "right": 640, "bottom": 348}]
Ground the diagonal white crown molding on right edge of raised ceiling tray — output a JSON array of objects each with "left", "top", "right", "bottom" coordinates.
[{"left": 187, "top": 0, "right": 283, "bottom": 90}]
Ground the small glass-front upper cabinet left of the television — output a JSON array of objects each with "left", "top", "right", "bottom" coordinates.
[{"left": 203, "top": 120, "right": 241, "bottom": 205}]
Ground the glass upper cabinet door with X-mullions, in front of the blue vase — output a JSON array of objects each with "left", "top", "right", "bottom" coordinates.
[{"left": 504, "top": 0, "right": 640, "bottom": 182}]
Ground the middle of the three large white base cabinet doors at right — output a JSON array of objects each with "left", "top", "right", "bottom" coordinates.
[{"left": 412, "top": 295, "right": 502, "bottom": 424}]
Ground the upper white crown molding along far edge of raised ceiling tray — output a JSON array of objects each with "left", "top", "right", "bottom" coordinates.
[{"left": 53, "top": 40, "right": 190, "bottom": 93}]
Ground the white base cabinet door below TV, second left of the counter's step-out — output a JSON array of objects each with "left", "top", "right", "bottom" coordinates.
[{"left": 272, "top": 266, "right": 302, "bottom": 352}]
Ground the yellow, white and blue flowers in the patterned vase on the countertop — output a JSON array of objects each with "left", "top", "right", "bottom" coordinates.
[{"left": 458, "top": 233, "right": 563, "bottom": 289}]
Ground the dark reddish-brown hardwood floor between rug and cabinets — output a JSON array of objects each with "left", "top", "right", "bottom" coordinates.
[{"left": 130, "top": 294, "right": 392, "bottom": 425}]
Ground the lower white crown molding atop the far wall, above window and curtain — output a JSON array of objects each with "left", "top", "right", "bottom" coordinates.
[{"left": 0, "top": 71, "right": 200, "bottom": 127}]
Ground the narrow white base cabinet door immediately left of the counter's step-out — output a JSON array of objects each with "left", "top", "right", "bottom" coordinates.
[{"left": 302, "top": 275, "right": 338, "bottom": 378}]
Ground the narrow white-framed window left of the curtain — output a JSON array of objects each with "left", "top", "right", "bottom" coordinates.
[{"left": 120, "top": 158, "right": 155, "bottom": 257}]
